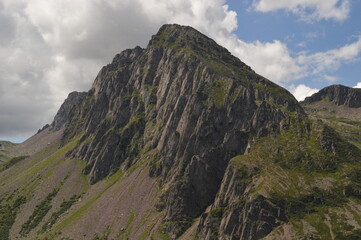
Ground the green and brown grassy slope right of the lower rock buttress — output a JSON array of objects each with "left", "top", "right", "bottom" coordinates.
[{"left": 232, "top": 118, "right": 361, "bottom": 239}]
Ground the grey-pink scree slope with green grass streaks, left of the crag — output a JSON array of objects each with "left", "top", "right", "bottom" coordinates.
[{"left": 0, "top": 131, "right": 166, "bottom": 240}]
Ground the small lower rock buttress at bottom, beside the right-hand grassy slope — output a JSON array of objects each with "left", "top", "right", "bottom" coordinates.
[{"left": 197, "top": 162, "right": 288, "bottom": 240}]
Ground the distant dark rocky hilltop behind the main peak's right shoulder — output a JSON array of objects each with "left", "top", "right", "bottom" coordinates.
[{"left": 303, "top": 85, "right": 361, "bottom": 108}]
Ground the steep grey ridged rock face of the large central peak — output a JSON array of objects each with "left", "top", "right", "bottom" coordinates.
[{"left": 56, "top": 25, "right": 305, "bottom": 239}]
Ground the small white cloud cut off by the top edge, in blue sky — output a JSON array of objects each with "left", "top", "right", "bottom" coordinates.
[{"left": 253, "top": 0, "right": 350, "bottom": 22}]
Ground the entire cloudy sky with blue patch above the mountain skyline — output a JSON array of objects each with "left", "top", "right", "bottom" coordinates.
[{"left": 0, "top": 0, "right": 361, "bottom": 142}]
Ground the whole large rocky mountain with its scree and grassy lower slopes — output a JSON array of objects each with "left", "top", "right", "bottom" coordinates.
[{"left": 0, "top": 25, "right": 361, "bottom": 240}]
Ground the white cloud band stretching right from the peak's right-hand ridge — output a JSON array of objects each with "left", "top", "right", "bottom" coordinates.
[{"left": 216, "top": 34, "right": 361, "bottom": 84}]
